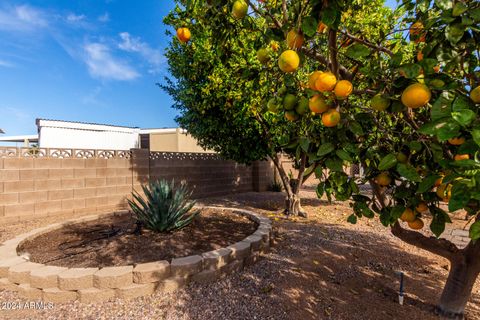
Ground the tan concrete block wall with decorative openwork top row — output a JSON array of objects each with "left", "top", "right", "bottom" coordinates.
[{"left": 0, "top": 148, "right": 273, "bottom": 223}]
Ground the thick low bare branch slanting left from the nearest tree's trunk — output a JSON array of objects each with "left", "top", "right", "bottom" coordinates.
[{"left": 391, "top": 221, "right": 460, "bottom": 261}]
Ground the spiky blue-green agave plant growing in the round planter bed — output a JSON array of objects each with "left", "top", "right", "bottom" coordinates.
[{"left": 128, "top": 180, "right": 199, "bottom": 232}]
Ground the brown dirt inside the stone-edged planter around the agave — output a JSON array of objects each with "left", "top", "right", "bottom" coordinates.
[{"left": 19, "top": 209, "right": 257, "bottom": 268}]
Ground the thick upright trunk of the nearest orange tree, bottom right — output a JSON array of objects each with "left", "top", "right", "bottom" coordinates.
[{"left": 437, "top": 251, "right": 480, "bottom": 319}]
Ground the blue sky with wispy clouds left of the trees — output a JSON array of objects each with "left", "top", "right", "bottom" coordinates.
[{"left": 0, "top": 0, "right": 395, "bottom": 135}]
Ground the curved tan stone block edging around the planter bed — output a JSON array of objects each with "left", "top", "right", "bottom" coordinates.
[{"left": 0, "top": 207, "right": 272, "bottom": 303}]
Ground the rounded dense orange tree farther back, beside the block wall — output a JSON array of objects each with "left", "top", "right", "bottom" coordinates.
[{"left": 161, "top": 0, "right": 393, "bottom": 215}]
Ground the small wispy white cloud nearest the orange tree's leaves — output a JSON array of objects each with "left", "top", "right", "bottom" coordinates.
[{"left": 118, "top": 32, "right": 167, "bottom": 73}]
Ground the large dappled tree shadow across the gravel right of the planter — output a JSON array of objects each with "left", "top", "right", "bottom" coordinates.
[{"left": 177, "top": 194, "right": 480, "bottom": 320}]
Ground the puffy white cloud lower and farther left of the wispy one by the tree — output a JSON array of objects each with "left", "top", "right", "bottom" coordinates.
[{"left": 84, "top": 43, "right": 140, "bottom": 81}]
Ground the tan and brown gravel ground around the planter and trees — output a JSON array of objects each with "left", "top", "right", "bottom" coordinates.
[{"left": 0, "top": 191, "right": 480, "bottom": 320}]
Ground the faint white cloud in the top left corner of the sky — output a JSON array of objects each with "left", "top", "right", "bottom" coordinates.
[{"left": 0, "top": 5, "right": 48, "bottom": 31}]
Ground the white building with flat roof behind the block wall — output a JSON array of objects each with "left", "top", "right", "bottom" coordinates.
[{"left": 37, "top": 119, "right": 140, "bottom": 150}]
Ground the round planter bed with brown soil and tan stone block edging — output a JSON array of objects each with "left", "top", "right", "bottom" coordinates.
[{"left": 0, "top": 207, "right": 272, "bottom": 303}]
